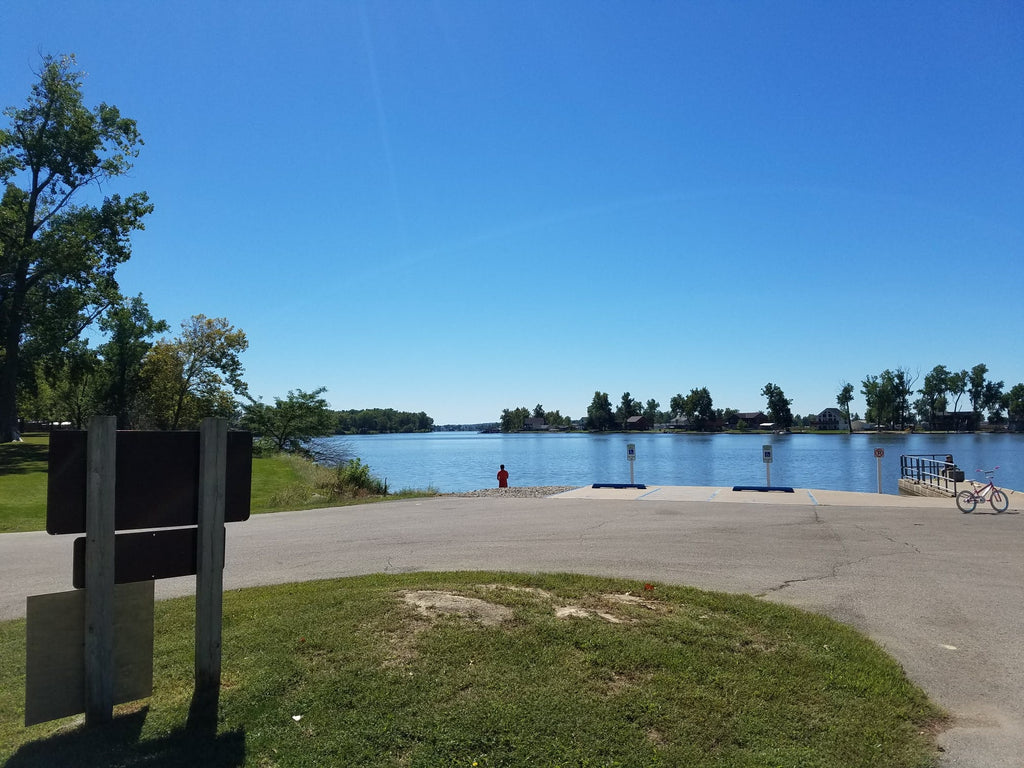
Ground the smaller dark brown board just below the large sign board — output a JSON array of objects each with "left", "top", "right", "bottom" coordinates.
[{"left": 72, "top": 528, "right": 205, "bottom": 589}]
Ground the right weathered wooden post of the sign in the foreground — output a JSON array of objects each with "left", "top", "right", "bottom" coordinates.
[{"left": 196, "top": 418, "right": 227, "bottom": 700}]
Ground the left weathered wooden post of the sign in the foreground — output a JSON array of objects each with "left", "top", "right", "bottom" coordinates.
[{"left": 85, "top": 416, "right": 118, "bottom": 726}]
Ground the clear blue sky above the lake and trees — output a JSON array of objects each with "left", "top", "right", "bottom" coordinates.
[{"left": 0, "top": 0, "right": 1024, "bottom": 424}]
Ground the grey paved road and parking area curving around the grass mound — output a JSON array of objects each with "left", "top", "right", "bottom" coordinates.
[{"left": 0, "top": 486, "right": 1024, "bottom": 768}]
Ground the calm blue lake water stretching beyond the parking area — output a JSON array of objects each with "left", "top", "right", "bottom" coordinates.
[{"left": 317, "top": 432, "right": 1024, "bottom": 494}]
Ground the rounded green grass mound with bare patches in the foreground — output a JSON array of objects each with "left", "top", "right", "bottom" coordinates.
[{"left": 0, "top": 573, "right": 942, "bottom": 768}]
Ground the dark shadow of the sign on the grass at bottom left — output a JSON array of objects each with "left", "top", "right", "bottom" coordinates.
[{"left": 4, "top": 708, "right": 246, "bottom": 768}]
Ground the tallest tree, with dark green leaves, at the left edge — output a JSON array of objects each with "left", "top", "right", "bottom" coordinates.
[{"left": 0, "top": 56, "right": 153, "bottom": 442}]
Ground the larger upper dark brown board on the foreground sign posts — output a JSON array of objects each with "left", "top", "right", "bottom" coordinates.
[{"left": 46, "top": 431, "right": 253, "bottom": 536}]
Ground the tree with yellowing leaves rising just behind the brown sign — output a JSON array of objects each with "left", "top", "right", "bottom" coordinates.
[{"left": 140, "top": 314, "right": 249, "bottom": 429}]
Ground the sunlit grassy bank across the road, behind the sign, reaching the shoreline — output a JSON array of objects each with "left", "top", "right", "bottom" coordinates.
[{"left": 0, "top": 434, "right": 434, "bottom": 534}]
